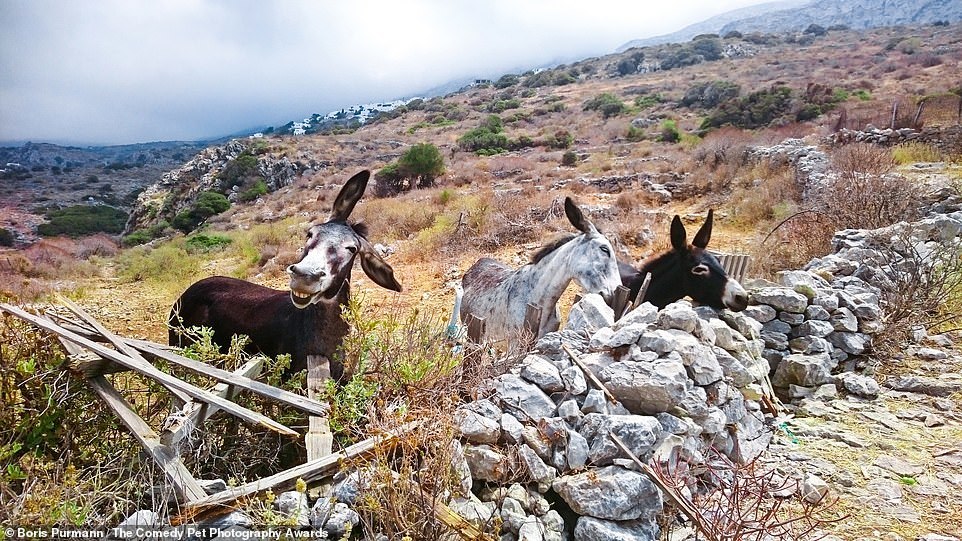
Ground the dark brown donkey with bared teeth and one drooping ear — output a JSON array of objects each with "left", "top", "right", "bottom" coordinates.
[{"left": 169, "top": 171, "right": 401, "bottom": 380}]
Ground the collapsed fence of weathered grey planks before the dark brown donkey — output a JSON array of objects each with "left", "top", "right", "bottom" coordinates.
[{"left": 0, "top": 299, "right": 444, "bottom": 528}]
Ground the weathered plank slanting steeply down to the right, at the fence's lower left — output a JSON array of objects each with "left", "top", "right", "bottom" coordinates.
[{"left": 87, "top": 376, "right": 207, "bottom": 503}]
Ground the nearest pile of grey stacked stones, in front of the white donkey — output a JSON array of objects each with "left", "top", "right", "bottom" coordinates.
[{"left": 452, "top": 295, "right": 771, "bottom": 541}]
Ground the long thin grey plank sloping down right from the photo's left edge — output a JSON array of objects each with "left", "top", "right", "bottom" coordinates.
[{"left": 0, "top": 303, "right": 298, "bottom": 437}]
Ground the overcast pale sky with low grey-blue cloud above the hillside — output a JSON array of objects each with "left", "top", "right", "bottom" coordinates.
[{"left": 0, "top": 0, "right": 761, "bottom": 144}]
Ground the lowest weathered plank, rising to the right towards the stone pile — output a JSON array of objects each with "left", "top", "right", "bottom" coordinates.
[{"left": 180, "top": 421, "right": 420, "bottom": 524}]
